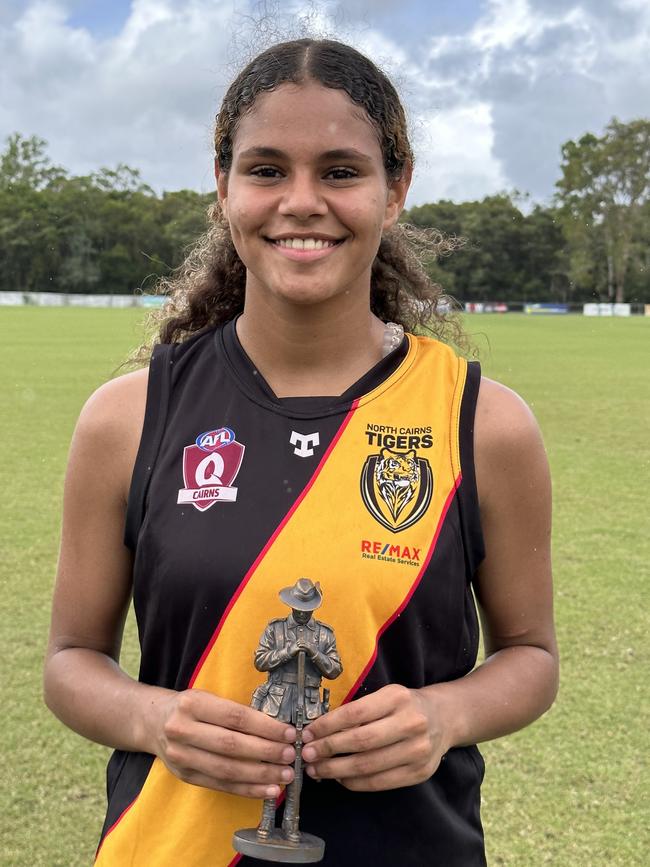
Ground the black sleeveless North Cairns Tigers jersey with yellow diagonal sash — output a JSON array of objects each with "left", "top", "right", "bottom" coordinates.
[{"left": 96, "top": 321, "right": 485, "bottom": 867}]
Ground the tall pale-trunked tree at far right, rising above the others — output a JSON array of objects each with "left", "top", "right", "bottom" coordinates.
[{"left": 556, "top": 118, "right": 650, "bottom": 302}]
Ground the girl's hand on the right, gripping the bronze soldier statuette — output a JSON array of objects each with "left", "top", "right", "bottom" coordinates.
[{"left": 302, "top": 684, "right": 450, "bottom": 792}]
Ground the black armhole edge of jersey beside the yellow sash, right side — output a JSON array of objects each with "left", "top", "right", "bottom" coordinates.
[{"left": 458, "top": 361, "right": 485, "bottom": 583}]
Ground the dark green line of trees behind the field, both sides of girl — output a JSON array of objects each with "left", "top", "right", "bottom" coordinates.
[{"left": 0, "top": 119, "right": 650, "bottom": 303}]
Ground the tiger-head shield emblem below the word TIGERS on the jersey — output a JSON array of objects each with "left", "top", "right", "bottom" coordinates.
[{"left": 361, "top": 448, "right": 433, "bottom": 533}]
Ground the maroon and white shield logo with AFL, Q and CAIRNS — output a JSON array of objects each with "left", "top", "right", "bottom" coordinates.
[{"left": 176, "top": 427, "right": 245, "bottom": 512}]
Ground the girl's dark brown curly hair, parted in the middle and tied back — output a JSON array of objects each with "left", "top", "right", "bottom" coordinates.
[{"left": 144, "top": 39, "right": 465, "bottom": 360}]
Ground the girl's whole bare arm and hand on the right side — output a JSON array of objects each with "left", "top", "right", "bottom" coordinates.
[{"left": 303, "top": 379, "right": 558, "bottom": 789}]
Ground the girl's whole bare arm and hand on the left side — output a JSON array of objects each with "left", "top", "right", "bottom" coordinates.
[{"left": 44, "top": 371, "right": 295, "bottom": 798}]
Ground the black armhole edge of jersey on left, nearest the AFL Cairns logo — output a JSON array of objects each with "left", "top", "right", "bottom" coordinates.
[{"left": 124, "top": 343, "right": 174, "bottom": 551}]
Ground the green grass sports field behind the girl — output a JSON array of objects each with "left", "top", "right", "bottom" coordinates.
[{"left": 0, "top": 308, "right": 650, "bottom": 867}]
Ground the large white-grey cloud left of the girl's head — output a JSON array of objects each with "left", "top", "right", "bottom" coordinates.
[{"left": 0, "top": 0, "right": 239, "bottom": 189}]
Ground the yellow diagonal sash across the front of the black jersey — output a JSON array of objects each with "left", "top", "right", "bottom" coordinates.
[{"left": 96, "top": 337, "right": 467, "bottom": 867}]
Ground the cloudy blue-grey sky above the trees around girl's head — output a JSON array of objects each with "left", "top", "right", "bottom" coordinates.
[{"left": 0, "top": 0, "right": 650, "bottom": 206}]
